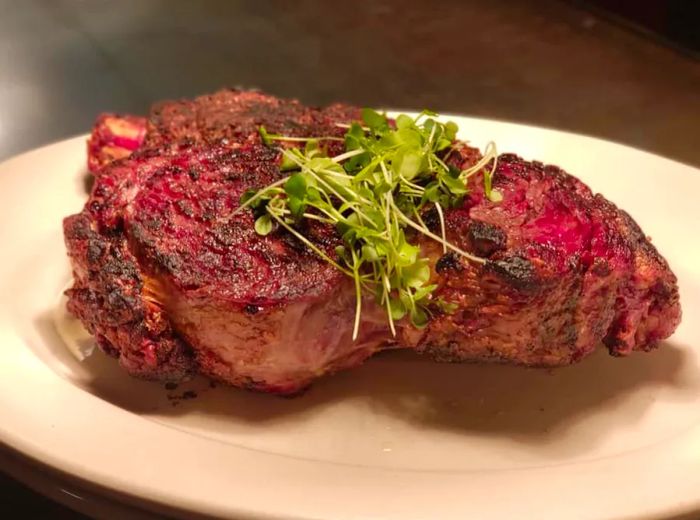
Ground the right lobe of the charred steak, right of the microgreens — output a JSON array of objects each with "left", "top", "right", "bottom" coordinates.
[{"left": 417, "top": 154, "right": 681, "bottom": 366}]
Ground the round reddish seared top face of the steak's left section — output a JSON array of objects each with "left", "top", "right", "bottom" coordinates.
[{"left": 125, "top": 144, "right": 343, "bottom": 306}]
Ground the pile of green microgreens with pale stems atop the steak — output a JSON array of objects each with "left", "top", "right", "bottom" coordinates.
[{"left": 237, "top": 109, "right": 501, "bottom": 338}]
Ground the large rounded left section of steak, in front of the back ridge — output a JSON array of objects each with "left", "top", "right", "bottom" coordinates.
[{"left": 64, "top": 144, "right": 386, "bottom": 393}]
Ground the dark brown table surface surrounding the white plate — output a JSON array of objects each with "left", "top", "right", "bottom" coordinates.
[{"left": 0, "top": 0, "right": 700, "bottom": 518}]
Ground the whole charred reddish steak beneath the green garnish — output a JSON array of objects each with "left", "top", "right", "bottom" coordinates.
[{"left": 64, "top": 90, "right": 681, "bottom": 394}]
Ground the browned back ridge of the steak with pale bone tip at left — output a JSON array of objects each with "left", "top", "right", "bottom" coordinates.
[{"left": 88, "top": 89, "right": 360, "bottom": 174}]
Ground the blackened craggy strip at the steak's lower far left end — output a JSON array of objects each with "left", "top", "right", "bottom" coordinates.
[{"left": 64, "top": 213, "right": 195, "bottom": 381}]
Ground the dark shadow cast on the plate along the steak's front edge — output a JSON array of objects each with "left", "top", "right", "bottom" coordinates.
[{"left": 31, "top": 304, "right": 700, "bottom": 450}]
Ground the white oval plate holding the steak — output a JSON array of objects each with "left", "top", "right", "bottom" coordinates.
[{"left": 0, "top": 118, "right": 700, "bottom": 520}]
